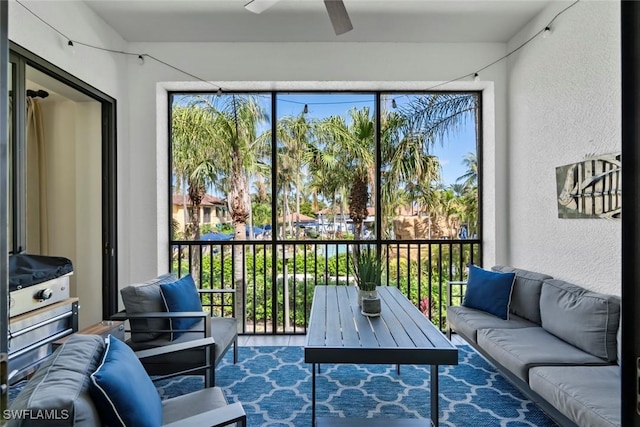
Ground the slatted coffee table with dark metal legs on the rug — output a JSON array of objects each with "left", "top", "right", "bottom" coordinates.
[{"left": 304, "top": 286, "right": 458, "bottom": 427}]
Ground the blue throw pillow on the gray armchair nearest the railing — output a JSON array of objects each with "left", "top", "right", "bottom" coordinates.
[{"left": 160, "top": 274, "right": 202, "bottom": 340}]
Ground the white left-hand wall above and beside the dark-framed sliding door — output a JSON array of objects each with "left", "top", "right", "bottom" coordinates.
[{"left": 9, "top": 0, "right": 135, "bottom": 290}]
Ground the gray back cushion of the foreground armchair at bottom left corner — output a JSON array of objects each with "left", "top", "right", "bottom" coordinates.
[{"left": 7, "top": 334, "right": 105, "bottom": 427}]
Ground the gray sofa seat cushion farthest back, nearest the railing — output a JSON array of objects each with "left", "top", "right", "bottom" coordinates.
[{"left": 447, "top": 306, "right": 538, "bottom": 343}]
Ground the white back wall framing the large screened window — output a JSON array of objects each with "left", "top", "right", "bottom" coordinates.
[{"left": 129, "top": 43, "right": 506, "bottom": 280}]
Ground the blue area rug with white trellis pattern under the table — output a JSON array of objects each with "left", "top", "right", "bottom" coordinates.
[{"left": 157, "top": 346, "right": 556, "bottom": 427}]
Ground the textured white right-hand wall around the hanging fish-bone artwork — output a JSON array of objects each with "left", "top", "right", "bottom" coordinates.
[{"left": 499, "top": 1, "right": 621, "bottom": 295}]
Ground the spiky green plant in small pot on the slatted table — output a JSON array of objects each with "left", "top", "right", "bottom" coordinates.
[{"left": 352, "top": 246, "right": 382, "bottom": 316}]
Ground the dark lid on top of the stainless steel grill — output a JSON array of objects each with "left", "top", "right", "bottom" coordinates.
[{"left": 9, "top": 254, "right": 73, "bottom": 291}]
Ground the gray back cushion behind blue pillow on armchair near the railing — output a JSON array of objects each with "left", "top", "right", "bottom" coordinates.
[{"left": 120, "top": 274, "right": 178, "bottom": 342}]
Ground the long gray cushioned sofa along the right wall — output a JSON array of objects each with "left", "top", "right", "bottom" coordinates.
[{"left": 447, "top": 266, "right": 621, "bottom": 427}]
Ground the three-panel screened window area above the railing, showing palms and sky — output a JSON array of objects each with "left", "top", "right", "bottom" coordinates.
[{"left": 171, "top": 92, "right": 480, "bottom": 241}]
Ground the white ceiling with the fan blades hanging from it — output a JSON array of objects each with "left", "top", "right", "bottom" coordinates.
[{"left": 85, "top": 0, "right": 555, "bottom": 42}]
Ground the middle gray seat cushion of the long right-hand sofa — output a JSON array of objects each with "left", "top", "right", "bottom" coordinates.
[{"left": 478, "top": 326, "right": 606, "bottom": 382}]
